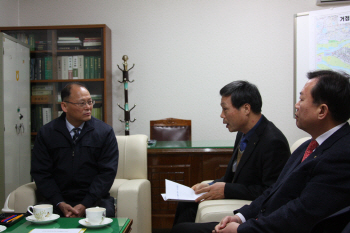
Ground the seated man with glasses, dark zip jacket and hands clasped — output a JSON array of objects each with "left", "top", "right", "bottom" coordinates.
[{"left": 31, "top": 83, "right": 118, "bottom": 217}]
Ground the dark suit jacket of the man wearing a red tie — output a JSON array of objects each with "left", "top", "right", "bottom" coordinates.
[{"left": 234, "top": 123, "right": 350, "bottom": 233}]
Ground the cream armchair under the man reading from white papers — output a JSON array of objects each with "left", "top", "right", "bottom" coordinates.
[{"left": 196, "top": 137, "right": 310, "bottom": 223}]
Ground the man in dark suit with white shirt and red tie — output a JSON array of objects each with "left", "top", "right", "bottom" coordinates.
[{"left": 172, "top": 70, "right": 350, "bottom": 233}]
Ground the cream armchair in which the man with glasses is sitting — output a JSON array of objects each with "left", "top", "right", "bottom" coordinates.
[{"left": 2, "top": 135, "right": 152, "bottom": 233}]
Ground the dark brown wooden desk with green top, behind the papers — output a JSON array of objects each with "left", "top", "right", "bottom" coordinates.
[{"left": 148, "top": 140, "right": 234, "bottom": 229}]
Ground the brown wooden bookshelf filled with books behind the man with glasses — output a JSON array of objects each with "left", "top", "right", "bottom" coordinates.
[{"left": 0, "top": 24, "right": 112, "bottom": 136}]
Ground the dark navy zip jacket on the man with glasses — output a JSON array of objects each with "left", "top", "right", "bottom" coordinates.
[{"left": 31, "top": 113, "right": 119, "bottom": 208}]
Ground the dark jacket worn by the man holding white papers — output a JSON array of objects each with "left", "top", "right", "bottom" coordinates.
[{"left": 214, "top": 116, "right": 290, "bottom": 200}]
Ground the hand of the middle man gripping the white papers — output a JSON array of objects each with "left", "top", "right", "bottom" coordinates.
[{"left": 192, "top": 182, "right": 226, "bottom": 202}]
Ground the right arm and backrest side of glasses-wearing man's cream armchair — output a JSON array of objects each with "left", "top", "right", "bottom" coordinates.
[{"left": 110, "top": 135, "right": 152, "bottom": 233}]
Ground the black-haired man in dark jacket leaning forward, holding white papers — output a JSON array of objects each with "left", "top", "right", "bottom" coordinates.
[{"left": 174, "top": 81, "right": 290, "bottom": 225}]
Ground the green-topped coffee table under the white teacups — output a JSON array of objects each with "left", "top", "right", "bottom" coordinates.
[{"left": 3, "top": 218, "right": 132, "bottom": 233}]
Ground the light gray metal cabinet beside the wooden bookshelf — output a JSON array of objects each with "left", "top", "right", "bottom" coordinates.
[{"left": 0, "top": 33, "right": 31, "bottom": 205}]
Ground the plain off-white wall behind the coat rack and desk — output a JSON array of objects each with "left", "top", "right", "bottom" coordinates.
[{"left": 0, "top": 0, "right": 348, "bottom": 146}]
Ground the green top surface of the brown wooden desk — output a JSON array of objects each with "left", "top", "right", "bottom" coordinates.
[{"left": 148, "top": 140, "right": 234, "bottom": 149}]
